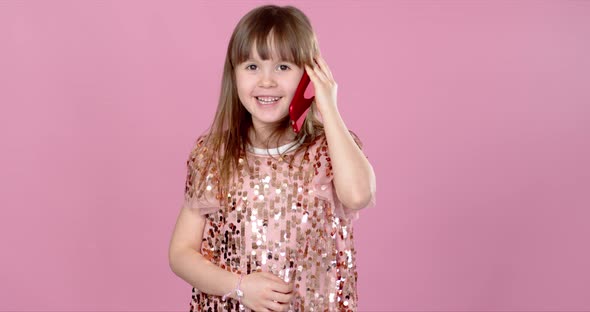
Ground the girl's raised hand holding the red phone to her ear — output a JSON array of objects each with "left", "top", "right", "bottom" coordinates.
[{"left": 305, "top": 54, "right": 338, "bottom": 116}]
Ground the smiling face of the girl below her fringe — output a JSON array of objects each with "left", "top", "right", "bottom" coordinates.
[{"left": 235, "top": 45, "right": 305, "bottom": 130}]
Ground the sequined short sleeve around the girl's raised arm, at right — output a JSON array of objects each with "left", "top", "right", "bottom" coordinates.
[{"left": 312, "top": 136, "right": 376, "bottom": 221}]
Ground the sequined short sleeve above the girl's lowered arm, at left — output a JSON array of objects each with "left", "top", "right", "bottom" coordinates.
[{"left": 183, "top": 136, "right": 221, "bottom": 215}]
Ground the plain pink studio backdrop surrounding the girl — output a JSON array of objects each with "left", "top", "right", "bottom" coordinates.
[{"left": 0, "top": 0, "right": 590, "bottom": 311}]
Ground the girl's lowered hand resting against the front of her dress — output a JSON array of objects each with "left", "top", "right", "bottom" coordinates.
[{"left": 240, "top": 272, "right": 294, "bottom": 312}]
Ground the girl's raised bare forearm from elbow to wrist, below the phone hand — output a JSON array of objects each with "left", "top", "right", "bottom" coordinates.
[{"left": 321, "top": 106, "right": 376, "bottom": 209}]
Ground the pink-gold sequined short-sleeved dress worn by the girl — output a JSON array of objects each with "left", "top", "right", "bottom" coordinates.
[{"left": 183, "top": 135, "right": 375, "bottom": 311}]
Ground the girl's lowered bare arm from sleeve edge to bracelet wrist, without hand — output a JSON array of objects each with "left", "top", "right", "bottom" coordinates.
[{"left": 168, "top": 208, "right": 239, "bottom": 299}]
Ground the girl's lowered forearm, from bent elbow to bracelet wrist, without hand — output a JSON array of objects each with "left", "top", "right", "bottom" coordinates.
[{"left": 170, "top": 248, "right": 239, "bottom": 299}]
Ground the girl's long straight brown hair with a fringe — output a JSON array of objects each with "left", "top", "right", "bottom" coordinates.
[{"left": 196, "top": 5, "right": 360, "bottom": 199}]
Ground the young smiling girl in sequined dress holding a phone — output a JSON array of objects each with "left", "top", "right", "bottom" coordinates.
[{"left": 169, "top": 5, "right": 376, "bottom": 311}]
